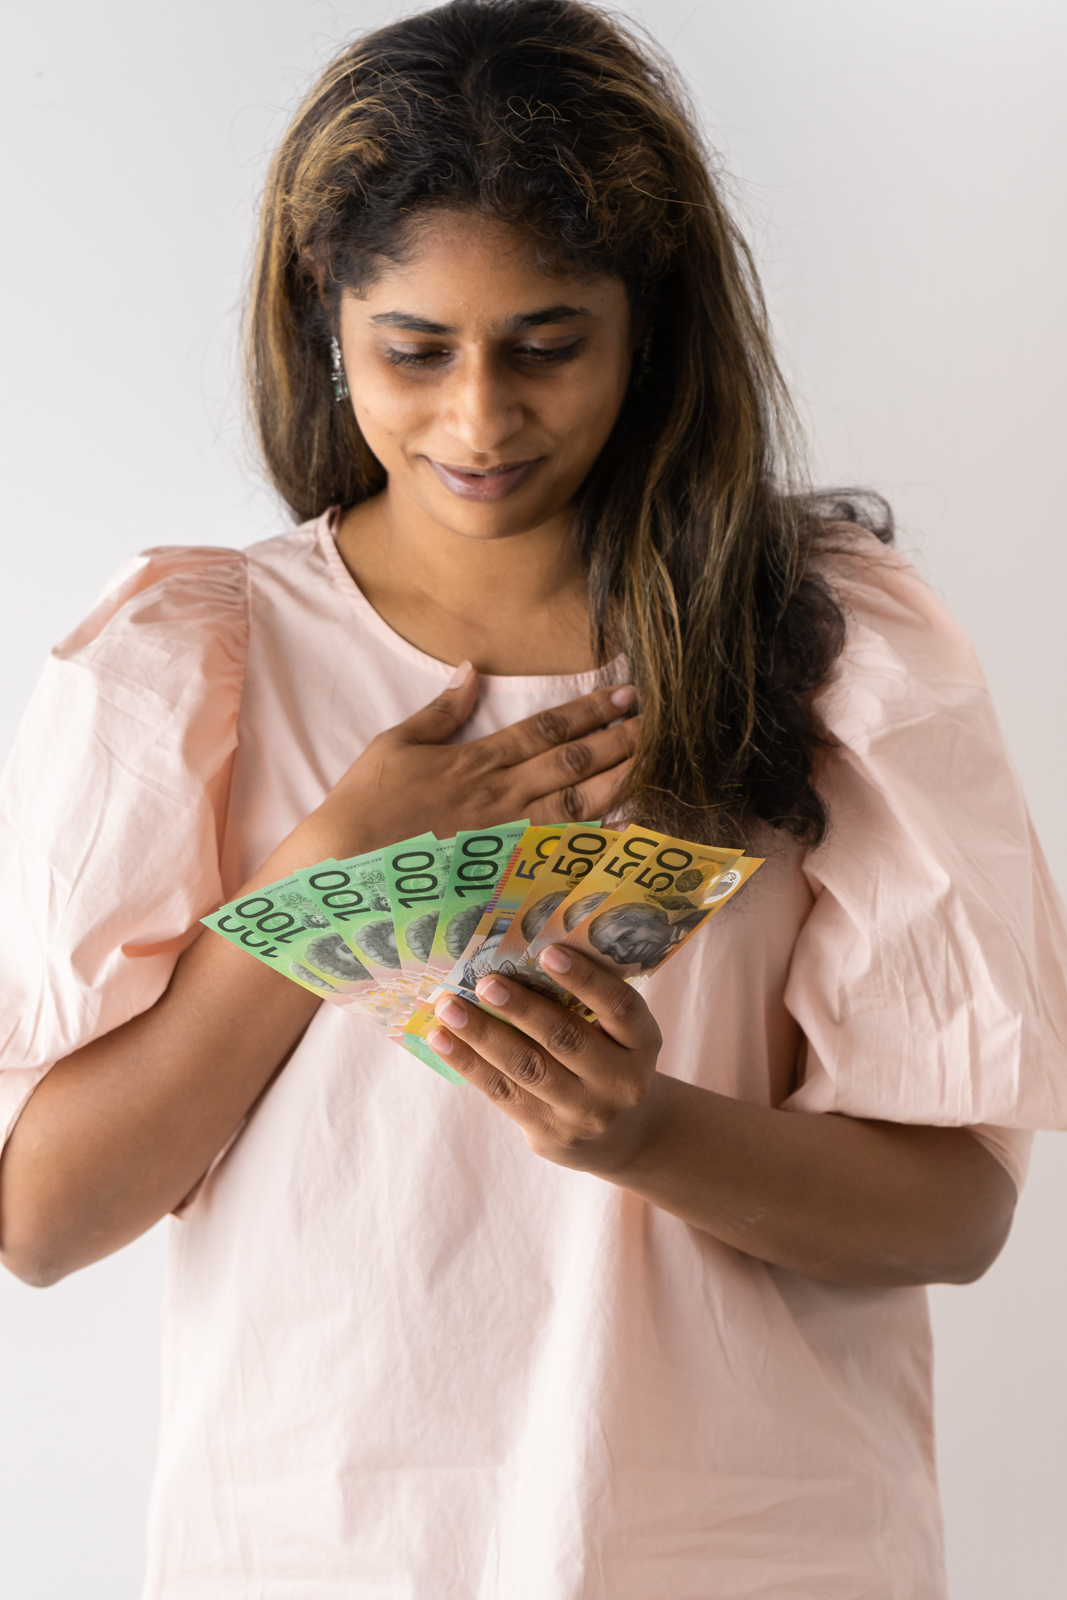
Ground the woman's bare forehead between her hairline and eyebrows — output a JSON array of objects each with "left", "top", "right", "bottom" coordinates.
[{"left": 346, "top": 211, "right": 629, "bottom": 322}]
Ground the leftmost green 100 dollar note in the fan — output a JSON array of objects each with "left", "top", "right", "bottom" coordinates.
[{"left": 202, "top": 877, "right": 378, "bottom": 1005}]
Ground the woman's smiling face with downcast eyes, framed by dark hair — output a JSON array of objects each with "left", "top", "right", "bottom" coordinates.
[{"left": 341, "top": 211, "right": 633, "bottom": 539}]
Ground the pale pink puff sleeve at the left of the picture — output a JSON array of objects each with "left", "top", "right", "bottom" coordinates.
[{"left": 0, "top": 547, "right": 248, "bottom": 1141}]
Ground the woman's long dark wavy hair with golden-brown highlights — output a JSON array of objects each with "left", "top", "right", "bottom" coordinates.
[{"left": 248, "top": 0, "right": 891, "bottom": 843}]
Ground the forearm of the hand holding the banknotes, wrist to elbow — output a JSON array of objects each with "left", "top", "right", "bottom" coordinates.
[{"left": 609, "top": 1074, "right": 1016, "bottom": 1286}]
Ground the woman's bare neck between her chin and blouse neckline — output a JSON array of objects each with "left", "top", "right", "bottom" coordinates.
[{"left": 338, "top": 473, "right": 593, "bottom": 677}]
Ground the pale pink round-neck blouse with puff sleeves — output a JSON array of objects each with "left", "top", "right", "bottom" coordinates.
[{"left": 0, "top": 517, "right": 1067, "bottom": 1600}]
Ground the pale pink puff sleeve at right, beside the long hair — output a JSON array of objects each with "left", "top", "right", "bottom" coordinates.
[{"left": 785, "top": 534, "right": 1067, "bottom": 1132}]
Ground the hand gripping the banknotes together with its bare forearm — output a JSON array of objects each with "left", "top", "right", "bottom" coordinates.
[{"left": 429, "top": 946, "right": 1014, "bottom": 1286}]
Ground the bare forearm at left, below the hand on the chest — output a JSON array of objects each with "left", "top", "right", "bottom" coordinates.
[{"left": 0, "top": 933, "right": 318, "bottom": 1283}]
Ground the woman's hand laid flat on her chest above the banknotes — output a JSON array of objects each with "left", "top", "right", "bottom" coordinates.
[{"left": 302, "top": 662, "right": 638, "bottom": 875}]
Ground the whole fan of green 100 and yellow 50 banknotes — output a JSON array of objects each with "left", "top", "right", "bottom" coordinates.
[{"left": 203, "top": 822, "right": 761, "bottom": 1083}]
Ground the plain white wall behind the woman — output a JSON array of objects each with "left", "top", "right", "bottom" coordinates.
[{"left": 0, "top": 0, "right": 1067, "bottom": 1600}]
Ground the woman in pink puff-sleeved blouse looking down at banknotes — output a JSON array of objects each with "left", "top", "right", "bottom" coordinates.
[{"left": 0, "top": 0, "right": 1067, "bottom": 1600}]
